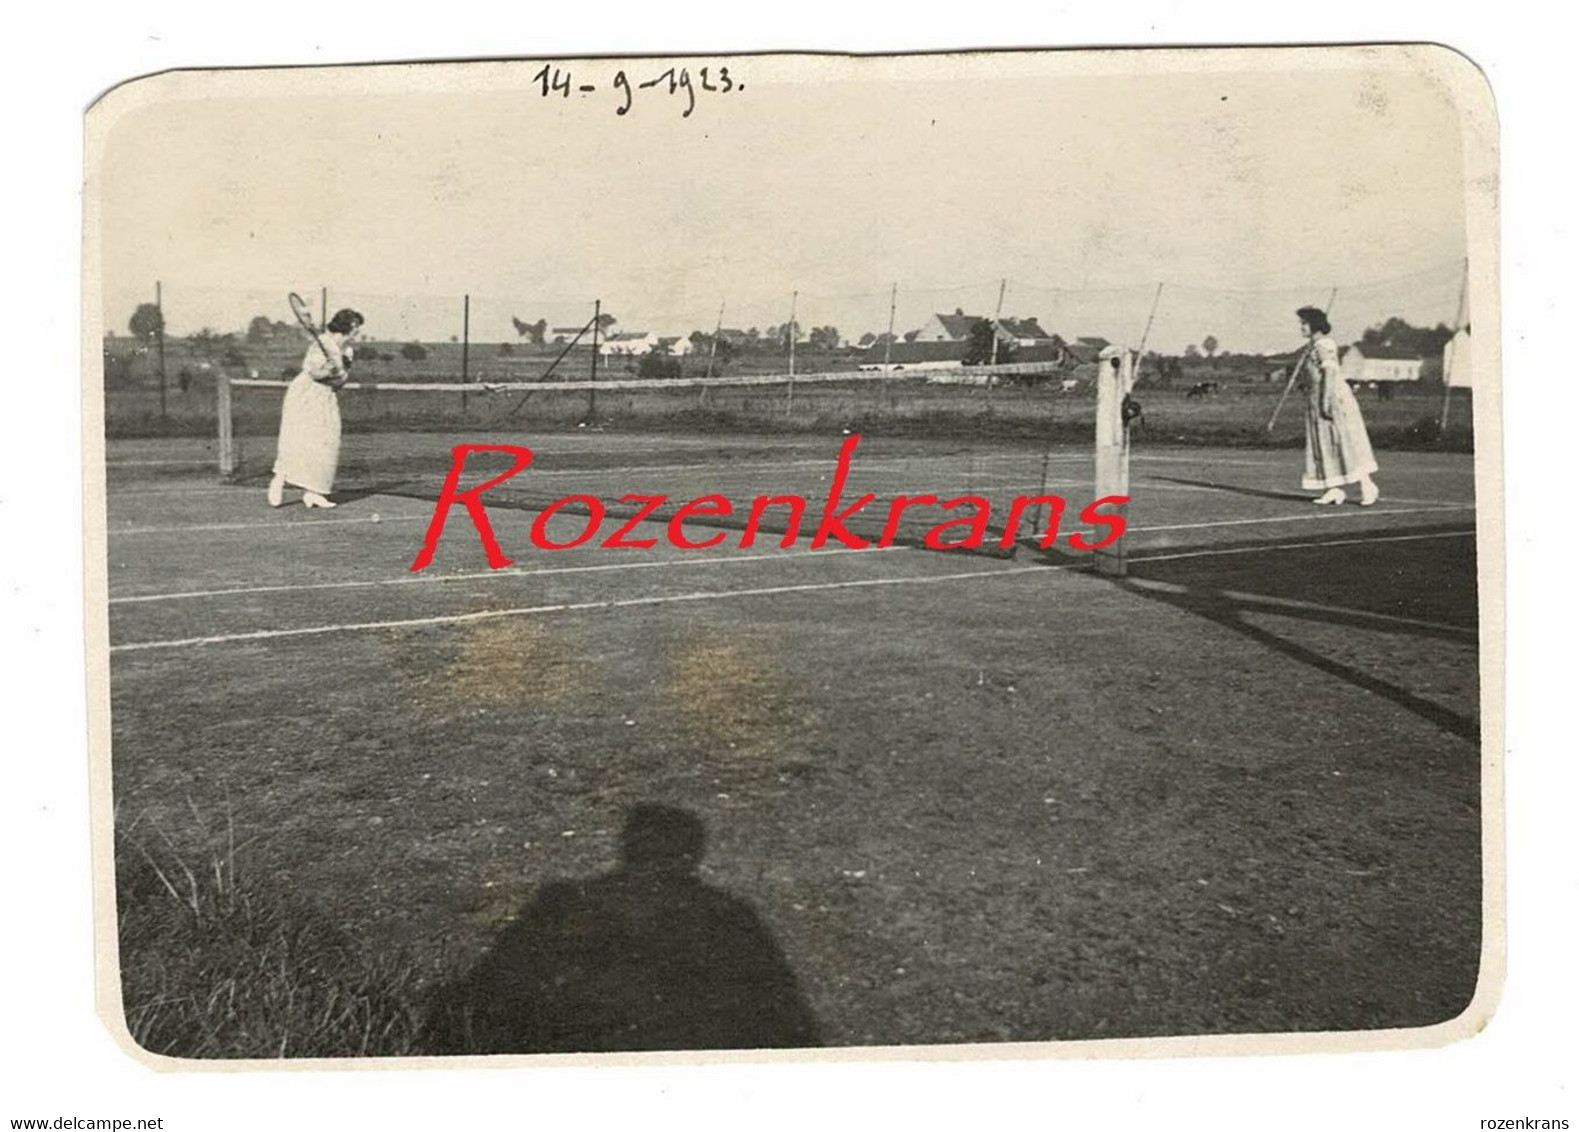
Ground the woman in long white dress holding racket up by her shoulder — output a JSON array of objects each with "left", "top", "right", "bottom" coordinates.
[{"left": 268, "top": 309, "right": 365, "bottom": 507}]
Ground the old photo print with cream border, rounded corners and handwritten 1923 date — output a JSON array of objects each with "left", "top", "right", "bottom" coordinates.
[{"left": 84, "top": 46, "right": 1503, "bottom": 1064}]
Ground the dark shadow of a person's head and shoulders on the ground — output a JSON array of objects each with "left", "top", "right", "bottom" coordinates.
[{"left": 423, "top": 805, "right": 821, "bottom": 1055}]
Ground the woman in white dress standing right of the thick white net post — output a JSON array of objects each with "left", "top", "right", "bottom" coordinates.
[{"left": 1296, "top": 306, "right": 1382, "bottom": 507}]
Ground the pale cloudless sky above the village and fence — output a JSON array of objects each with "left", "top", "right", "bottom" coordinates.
[{"left": 88, "top": 49, "right": 1465, "bottom": 350}]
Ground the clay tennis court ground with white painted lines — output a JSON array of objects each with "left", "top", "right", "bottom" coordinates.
[{"left": 107, "top": 431, "right": 1481, "bottom": 1045}]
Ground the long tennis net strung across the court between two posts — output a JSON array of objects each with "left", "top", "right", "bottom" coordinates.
[{"left": 218, "top": 363, "right": 1094, "bottom": 551}]
